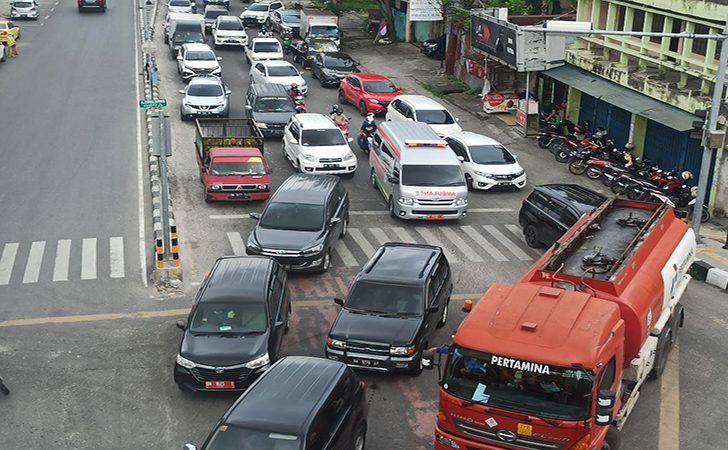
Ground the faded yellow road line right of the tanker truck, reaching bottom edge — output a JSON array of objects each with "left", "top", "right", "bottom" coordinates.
[{"left": 657, "top": 342, "right": 680, "bottom": 450}]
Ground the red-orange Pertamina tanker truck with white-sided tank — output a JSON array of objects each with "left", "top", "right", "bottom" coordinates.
[{"left": 423, "top": 199, "right": 695, "bottom": 450}]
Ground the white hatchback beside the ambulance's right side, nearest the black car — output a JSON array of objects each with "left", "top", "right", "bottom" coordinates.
[{"left": 445, "top": 131, "right": 526, "bottom": 190}]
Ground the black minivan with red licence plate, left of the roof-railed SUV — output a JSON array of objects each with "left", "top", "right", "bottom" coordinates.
[{"left": 174, "top": 256, "right": 291, "bottom": 391}]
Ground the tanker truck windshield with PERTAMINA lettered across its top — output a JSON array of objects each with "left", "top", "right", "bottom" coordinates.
[{"left": 443, "top": 346, "right": 594, "bottom": 420}]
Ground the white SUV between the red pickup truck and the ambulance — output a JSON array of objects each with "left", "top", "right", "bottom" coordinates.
[{"left": 283, "top": 114, "right": 356, "bottom": 175}]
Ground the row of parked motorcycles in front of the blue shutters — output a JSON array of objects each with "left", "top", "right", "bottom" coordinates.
[{"left": 538, "top": 115, "right": 710, "bottom": 222}]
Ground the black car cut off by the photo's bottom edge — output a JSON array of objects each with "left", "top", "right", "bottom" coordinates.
[{"left": 185, "top": 356, "right": 368, "bottom": 450}]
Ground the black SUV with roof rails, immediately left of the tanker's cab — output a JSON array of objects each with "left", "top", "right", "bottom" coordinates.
[{"left": 326, "top": 243, "right": 452, "bottom": 374}]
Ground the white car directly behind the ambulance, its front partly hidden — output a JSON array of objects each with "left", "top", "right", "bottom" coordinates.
[{"left": 386, "top": 95, "right": 463, "bottom": 136}]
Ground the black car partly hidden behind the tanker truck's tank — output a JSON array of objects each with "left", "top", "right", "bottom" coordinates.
[{"left": 518, "top": 184, "right": 607, "bottom": 248}]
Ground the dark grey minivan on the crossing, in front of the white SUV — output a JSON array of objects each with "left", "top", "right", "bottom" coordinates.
[{"left": 245, "top": 173, "right": 349, "bottom": 272}]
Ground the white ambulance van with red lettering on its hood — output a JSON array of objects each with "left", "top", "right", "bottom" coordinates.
[{"left": 369, "top": 122, "right": 468, "bottom": 220}]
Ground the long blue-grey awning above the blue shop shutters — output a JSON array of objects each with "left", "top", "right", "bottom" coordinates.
[{"left": 542, "top": 64, "right": 699, "bottom": 131}]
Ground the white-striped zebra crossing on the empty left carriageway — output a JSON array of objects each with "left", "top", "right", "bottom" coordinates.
[{"left": 0, "top": 236, "right": 126, "bottom": 286}]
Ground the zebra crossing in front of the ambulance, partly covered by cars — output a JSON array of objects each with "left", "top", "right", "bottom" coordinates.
[{"left": 227, "top": 224, "right": 541, "bottom": 267}]
